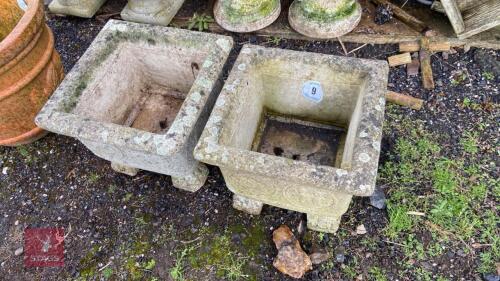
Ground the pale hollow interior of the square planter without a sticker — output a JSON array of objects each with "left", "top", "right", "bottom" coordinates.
[{"left": 73, "top": 43, "right": 201, "bottom": 133}]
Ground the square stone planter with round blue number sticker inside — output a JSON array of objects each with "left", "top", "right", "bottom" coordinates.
[{"left": 194, "top": 45, "right": 389, "bottom": 233}]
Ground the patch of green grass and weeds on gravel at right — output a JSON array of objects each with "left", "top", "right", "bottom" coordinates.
[{"left": 380, "top": 114, "right": 500, "bottom": 280}]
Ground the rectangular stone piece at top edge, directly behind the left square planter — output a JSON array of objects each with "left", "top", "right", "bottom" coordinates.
[{"left": 121, "top": 0, "right": 184, "bottom": 26}]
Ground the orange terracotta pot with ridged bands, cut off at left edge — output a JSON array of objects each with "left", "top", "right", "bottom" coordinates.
[{"left": 0, "top": 0, "right": 64, "bottom": 146}]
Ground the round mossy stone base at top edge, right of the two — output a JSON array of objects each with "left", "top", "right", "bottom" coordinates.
[{"left": 288, "top": 0, "right": 361, "bottom": 38}]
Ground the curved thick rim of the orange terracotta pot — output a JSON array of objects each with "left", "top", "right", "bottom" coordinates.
[{"left": 0, "top": 0, "right": 44, "bottom": 68}]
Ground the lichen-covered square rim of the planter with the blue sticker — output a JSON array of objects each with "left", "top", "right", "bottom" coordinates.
[{"left": 194, "top": 45, "right": 389, "bottom": 196}]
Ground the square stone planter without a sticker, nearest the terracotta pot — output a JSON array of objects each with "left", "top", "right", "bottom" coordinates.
[{"left": 36, "top": 20, "right": 233, "bottom": 191}]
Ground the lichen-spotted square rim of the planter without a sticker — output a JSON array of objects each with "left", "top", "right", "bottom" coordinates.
[{"left": 35, "top": 20, "right": 233, "bottom": 156}]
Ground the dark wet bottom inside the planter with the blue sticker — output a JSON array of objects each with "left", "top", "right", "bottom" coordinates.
[{"left": 253, "top": 113, "right": 346, "bottom": 167}]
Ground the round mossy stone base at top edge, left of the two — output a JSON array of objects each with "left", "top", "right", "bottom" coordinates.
[{"left": 214, "top": 0, "right": 281, "bottom": 32}]
